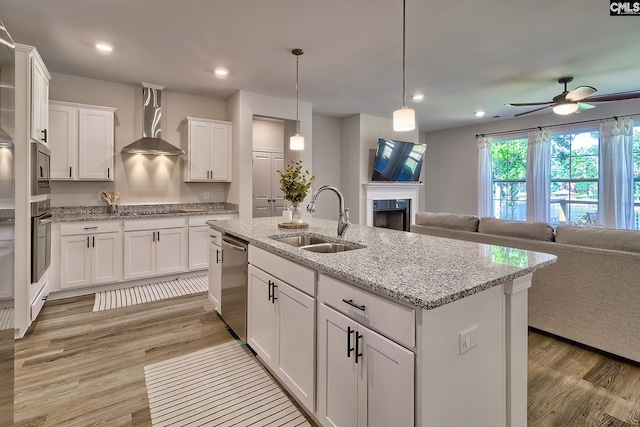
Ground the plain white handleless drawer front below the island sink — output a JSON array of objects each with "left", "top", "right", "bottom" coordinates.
[{"left": 248, "top": 245, "right": 316, "bottom": 296}]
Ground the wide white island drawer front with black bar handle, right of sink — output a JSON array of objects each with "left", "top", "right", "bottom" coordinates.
[{"left": 318, "top": 274, "right": 416, "bottom": 348}]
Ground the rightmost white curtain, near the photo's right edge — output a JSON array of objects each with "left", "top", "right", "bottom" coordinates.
[{"left": 598, "top": 117, "right": 633, "bottom": 228}]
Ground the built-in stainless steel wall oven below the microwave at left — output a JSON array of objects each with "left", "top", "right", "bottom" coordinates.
[{"left": 31, "top": 200, "right": 53, "bottom": 283}]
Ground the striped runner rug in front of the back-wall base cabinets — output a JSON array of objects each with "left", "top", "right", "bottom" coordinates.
[{"left": 93, "top": 276, "right": 209, "bottom": 311}]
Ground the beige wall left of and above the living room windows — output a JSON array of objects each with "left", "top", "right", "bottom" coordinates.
[{"left": 424, "top": 99, "right": 640, "bottom": 215}]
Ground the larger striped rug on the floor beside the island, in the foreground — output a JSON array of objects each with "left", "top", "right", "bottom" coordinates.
[{"left": 144, "top": 341, "right": 310, "bottom": 427}]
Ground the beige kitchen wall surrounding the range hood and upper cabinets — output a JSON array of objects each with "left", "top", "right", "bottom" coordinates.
[{"left": 49, "top": 73, "right": 229, "bottom": 206}]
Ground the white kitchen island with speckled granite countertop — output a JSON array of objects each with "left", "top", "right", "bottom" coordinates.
[{"left": 208, "top": 218, "right": 555, "bottom": 427}]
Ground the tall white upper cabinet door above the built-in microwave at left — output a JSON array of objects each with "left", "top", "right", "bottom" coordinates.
[{"left": 30, "top": 48, "right": 51, "bottom": 145}]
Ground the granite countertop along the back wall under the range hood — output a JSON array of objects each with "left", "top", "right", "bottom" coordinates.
[{"left": 51, "top": 203, "right": 238, "bottom": 222}]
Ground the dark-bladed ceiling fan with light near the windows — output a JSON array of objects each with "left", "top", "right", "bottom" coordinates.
[{"left": 505, "top": 76, "right": 640, "bottom": 117}]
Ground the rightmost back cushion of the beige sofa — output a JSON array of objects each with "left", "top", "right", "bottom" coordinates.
[{"left": 556, "top": 225, "right": 640, "bottom": 253}]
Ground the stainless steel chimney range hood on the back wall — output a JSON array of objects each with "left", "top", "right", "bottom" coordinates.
[{"left": 120, "top": 83, "right": 184, "bottom": 156}]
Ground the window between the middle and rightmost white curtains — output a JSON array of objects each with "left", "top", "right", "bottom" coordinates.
[{"left": 550, "top": 131, "right": 599, "bottom": 225}]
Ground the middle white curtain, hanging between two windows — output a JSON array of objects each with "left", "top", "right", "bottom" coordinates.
[{"left": 526, "top": 128, "right": 551, "bottom": 222}]
